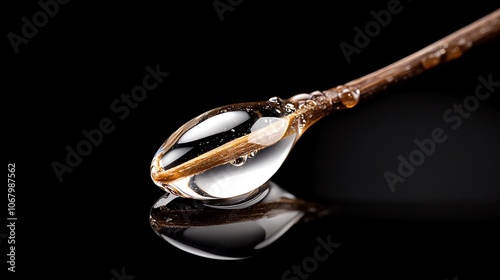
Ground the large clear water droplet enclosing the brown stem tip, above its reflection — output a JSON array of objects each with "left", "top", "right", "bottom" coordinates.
[{"left": 151, "top": 88, "right": 359, "bottom": 200}]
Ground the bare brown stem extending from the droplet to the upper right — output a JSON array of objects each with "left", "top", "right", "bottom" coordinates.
[{"left": 328, "top": 9, "right": 500, "bottom": 98}]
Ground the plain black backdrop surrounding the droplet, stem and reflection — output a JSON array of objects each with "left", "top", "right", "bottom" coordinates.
[{"left": 1, "top": 0, "right": 500, "bottom": 280}]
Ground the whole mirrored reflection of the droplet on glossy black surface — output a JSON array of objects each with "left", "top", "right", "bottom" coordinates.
[{"left": 150, "top": 182, "right": 328, "bottom": 260}]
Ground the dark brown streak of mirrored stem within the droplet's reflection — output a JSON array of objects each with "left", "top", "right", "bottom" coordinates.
[{"left": 151, "top": 198, "right": 334, "bottom": 228}]
